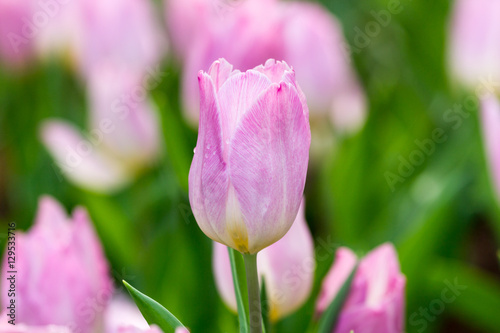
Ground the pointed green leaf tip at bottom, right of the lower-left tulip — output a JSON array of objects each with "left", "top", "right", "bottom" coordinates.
[{"left": 123, "top": 280, "right": 184, "bottom": 333}]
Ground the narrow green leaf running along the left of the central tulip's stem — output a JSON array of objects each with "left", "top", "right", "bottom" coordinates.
[{"left": 227, "top": 247, "right": 250, "bottom": 333}]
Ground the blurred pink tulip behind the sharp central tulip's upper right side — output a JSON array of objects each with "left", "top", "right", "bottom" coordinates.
[{"left": 283, "top": 2, "right": 367, "bottom": 132}]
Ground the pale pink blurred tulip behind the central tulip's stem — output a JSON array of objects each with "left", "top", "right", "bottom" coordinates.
[{"left": 213, "top": 200, "right": 315, "bottom": 321}]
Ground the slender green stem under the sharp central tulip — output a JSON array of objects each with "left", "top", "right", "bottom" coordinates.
[{"left": 243, "top": 254, "right": 262, "bottom": 333}]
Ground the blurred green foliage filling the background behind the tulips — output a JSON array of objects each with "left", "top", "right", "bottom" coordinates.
[{"left": 0, "top": 0, "right": 500, "bottom": 333}]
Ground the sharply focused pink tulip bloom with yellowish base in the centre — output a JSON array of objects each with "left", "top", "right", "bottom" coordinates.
[{"left": 189, "top": 59, "right": 311, "bottom": 254}]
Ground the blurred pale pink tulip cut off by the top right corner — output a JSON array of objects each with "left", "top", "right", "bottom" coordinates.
[{"left": 448, "top": 0, "right": 500, "bottom": 88}]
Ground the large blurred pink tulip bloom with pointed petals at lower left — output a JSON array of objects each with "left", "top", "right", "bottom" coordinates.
[{"left": 1, "top": 197, "right": 113, "bottom": 333}]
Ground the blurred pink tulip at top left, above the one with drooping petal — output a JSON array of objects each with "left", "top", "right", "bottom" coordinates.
[{"left": 76, "top": 0, "right": 166, "bottom": 76}]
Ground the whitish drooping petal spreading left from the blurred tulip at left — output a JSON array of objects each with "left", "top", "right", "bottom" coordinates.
[{"left": 41, "top": 120, "right": 129, "bottom": 192}]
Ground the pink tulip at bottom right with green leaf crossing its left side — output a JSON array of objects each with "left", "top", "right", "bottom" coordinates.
[{"left": 317, "top": 244, "right": 406, "bottom": 333}]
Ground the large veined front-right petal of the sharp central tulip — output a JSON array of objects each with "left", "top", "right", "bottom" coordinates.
[{"left": 229, "top": 83, "right": 311, "bottom": 253}]
